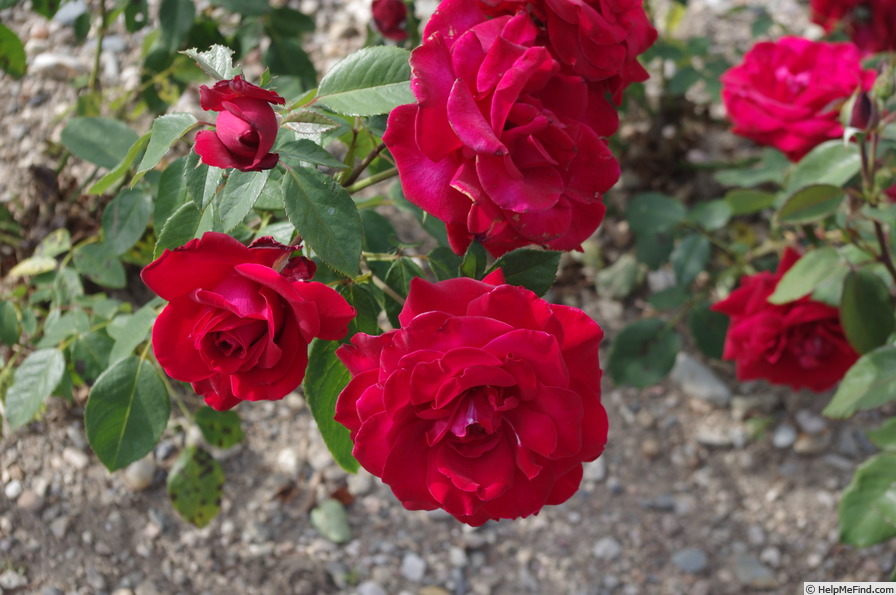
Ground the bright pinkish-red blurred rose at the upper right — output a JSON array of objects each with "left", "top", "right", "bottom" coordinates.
[{"left": 721, "top": 37, "right": 876, "bottom": 161}]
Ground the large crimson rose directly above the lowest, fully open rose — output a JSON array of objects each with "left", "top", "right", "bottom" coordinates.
[{"left": 383, "top": 8, "right": 619, "bottom": 256}]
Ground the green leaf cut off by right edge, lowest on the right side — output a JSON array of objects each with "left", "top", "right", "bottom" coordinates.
[{"left": 840, "top": 453, "right": 896, "bottom": 547}]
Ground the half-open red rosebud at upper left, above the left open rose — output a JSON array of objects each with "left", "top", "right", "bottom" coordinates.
[{"left": 194, "top": 75, "right": 286, "bottom": 171}]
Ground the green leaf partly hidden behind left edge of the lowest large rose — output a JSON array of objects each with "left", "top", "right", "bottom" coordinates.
[{"left": 303, "top": 339, "right": 359, "bottom": 473}]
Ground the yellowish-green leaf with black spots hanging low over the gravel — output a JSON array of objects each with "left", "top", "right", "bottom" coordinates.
[{"left": 168, "top": 446, "right": 224, "bottom": 528}]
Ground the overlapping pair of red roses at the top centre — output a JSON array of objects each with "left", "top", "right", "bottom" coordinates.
[{"left": 383, "top": 0, "right": 656, "bottom": 256}]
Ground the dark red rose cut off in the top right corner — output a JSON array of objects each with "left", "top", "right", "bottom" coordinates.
[{"left": 811, "top": 0, "right": 896, "bottom": 53}]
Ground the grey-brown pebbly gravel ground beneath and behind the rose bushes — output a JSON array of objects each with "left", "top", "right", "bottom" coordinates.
[{"left": 0, "top": 0, "right": 896, "bottom": 595}]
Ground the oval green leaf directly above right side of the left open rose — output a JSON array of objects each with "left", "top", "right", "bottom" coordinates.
[{"left": 283, "top": 167, "right": 362, "bottom": 277}]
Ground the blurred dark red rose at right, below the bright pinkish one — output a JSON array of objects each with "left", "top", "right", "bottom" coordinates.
[{"left": 712, "top": 248, "right": 859, "bottom": 392}]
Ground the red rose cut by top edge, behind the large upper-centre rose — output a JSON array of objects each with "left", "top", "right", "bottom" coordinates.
[{"left": 468, "top": 0, "right": 657, "bottom": 103}]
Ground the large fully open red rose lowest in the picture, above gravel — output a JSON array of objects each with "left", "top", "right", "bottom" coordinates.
[{"left": 336, "top": 271, "right": 607, "bottom": 526}]
